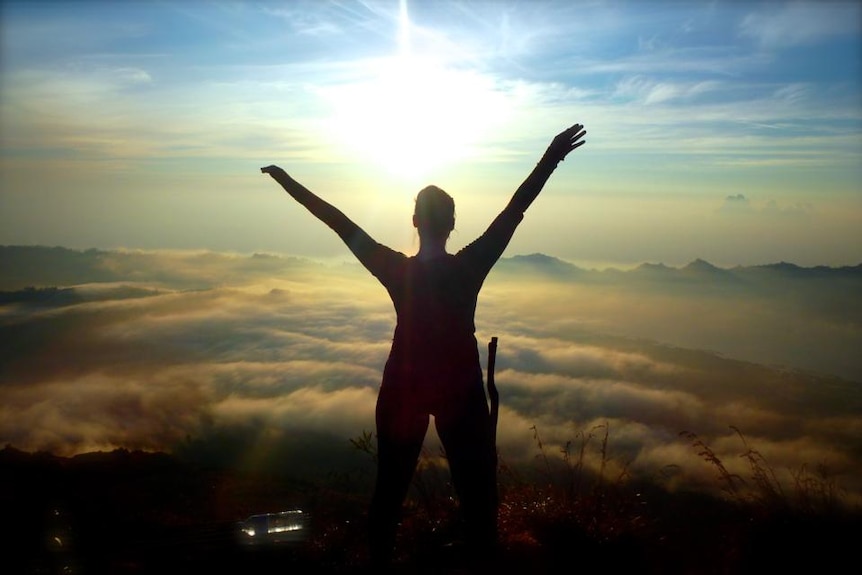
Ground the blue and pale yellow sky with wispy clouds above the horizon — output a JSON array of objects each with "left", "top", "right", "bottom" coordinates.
[{"left": 0, "top": 0, "right": 862, "bottom": 268}]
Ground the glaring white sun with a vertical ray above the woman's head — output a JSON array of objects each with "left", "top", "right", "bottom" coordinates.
[{"left": 327, "top": 4, "right": 505, "bottom": 177}]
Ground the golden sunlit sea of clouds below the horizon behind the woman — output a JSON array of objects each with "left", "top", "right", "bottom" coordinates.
[{"left": 0, "top": 248, "right": 862, "bottom": 504}]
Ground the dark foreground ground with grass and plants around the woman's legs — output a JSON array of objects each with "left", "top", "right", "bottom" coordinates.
[{"left": 0, "top": 426, "right": 862, "bottom": 574}]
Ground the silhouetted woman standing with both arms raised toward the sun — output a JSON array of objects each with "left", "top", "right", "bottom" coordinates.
[{"left": 261, "top": 124, "right": 586, "bottom": 565}]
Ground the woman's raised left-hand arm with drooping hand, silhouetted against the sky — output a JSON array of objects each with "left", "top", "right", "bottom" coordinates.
[{"left": 260, "top": 166, "right": 378, "bottom": 269}]
